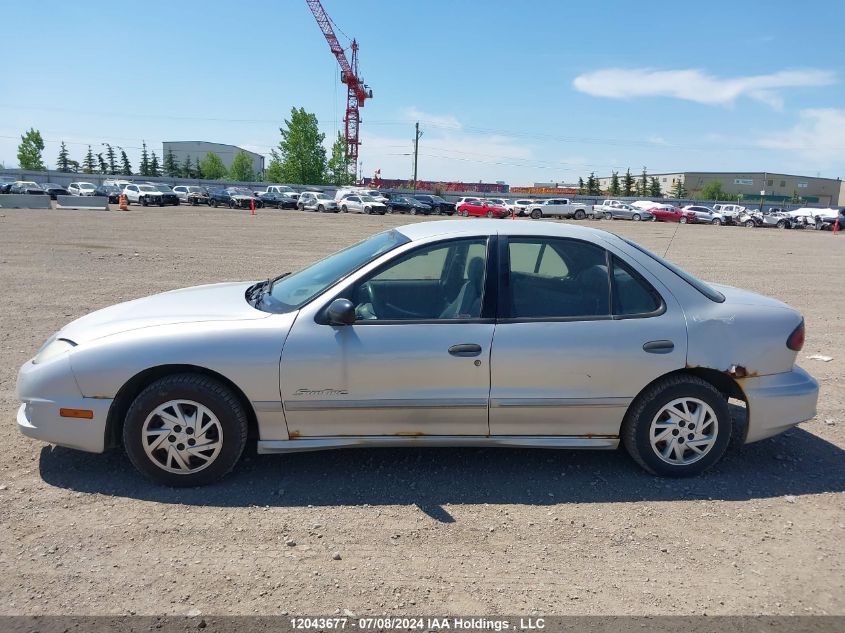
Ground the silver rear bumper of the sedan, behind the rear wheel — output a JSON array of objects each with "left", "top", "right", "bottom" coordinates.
[{"left": 741, "top": 366, "right": 819, "bottom": 443}]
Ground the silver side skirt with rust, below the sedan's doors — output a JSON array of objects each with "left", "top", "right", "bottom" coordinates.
[{"left": 258, "top": 435, "right": 619, "bottom": 454}]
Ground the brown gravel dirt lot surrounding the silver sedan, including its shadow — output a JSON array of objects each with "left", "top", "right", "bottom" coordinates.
[{"left": 0, "top": 207, "right": 845, "bottom": 615}]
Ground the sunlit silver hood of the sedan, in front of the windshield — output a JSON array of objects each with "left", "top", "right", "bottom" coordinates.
[{"left": 59, "top": 282, "right": 269, "bottom": 344}]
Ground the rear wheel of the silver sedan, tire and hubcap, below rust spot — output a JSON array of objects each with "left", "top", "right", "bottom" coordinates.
[{"left": 621, "top": 375, "right": 732, "bottom": 477}]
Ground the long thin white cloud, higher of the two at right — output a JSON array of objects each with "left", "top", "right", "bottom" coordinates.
[{"left": 572, "top": 68, "right": 836, "bottom": 108}]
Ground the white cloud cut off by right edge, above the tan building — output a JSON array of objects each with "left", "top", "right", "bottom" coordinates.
[{"left": 758, "top": 108, "right": 845, "bottom": 164}]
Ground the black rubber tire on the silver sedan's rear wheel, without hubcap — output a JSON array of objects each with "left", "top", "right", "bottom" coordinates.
[{"left": 621, "top": 374, "right": 733, "bottom": 477}]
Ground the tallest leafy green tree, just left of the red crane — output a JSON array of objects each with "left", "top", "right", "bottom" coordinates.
[{"left": 278, "top": 108, "right": 326, "bottom": 185}]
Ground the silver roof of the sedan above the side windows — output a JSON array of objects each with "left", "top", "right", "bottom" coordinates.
[{"left": 396, "top": 219, "right": 613, "bottom": 241}]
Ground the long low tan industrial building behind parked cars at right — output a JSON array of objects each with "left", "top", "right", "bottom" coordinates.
[{"left": 599, "top": 171, "right": 845, "bottom": 206}]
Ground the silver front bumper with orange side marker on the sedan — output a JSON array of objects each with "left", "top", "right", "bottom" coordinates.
[{"left": 17, "top": 355, "right": 112, "bottom": 453}]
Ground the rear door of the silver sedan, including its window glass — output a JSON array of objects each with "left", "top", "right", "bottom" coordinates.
[{"left": 490, "top": 237, "right": 686, "bottom": 437}]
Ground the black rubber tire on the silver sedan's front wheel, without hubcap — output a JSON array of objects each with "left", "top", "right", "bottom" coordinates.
[{"left": 123, "top": 374, "right": 248, "bottom": 487}]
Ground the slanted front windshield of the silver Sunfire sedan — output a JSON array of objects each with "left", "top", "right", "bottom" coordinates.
[{"left": 263, "top": 230, "right": 410, "bottom": 312}]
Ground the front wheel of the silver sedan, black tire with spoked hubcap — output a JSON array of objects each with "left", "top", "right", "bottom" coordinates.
[{"left": 123, "top": 374, "right": 247, "bottom": 487}]
